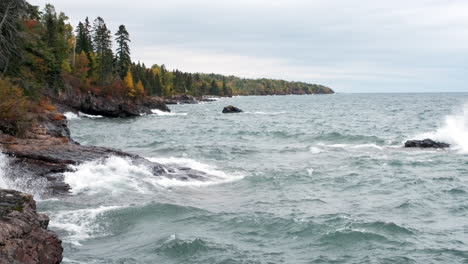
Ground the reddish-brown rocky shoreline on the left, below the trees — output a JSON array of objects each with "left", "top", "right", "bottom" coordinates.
[{"left": 0, "top": 95, "right": 216, "bottom": 264}]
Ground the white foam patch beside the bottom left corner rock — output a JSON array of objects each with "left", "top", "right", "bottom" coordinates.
[{"left": 46, "top": 206, "right": 123, "bottom": 246}]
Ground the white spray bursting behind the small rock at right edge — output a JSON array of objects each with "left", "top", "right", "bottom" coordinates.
[{"left": 414, "top": 103, "right": 468, "bottom": 154}]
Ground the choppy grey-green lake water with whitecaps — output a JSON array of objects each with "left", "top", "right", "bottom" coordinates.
[{"left": 0, "top": 94, "right": 468, "bottom": 264}]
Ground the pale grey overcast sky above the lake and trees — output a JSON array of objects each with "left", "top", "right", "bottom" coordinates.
[{"left": 29, "top": 0, "right": 468, "bottom": 93}]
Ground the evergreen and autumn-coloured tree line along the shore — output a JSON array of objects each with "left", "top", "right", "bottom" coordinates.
[{"left": 0, "top": 0, "right": 332, "bottom": 101}]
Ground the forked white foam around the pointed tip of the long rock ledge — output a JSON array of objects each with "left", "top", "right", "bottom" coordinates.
[{"left": 149, "top": 157, "right": 244, "bottom": 187}]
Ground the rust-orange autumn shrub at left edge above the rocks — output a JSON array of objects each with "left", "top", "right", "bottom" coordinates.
[{"left": 0, "top": 79, "right": 32, "bottom": 136}]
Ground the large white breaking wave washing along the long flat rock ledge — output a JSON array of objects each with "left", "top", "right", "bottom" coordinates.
[{"left": 64, "top": 156, "right": 243, "bottom": 195}]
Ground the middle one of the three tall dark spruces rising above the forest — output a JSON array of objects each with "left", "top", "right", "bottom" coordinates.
[{"left": 93, "top": 17, "right": 114, "bottom": 86}]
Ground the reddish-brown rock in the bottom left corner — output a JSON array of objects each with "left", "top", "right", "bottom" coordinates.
[{"left": 0, "top": 189, "right": 63, "bottom": 264}]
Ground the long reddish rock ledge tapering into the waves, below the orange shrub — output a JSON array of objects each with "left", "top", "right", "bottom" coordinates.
[{"left": 0, "top": 108, "right": 212, "bottom": 197}]
